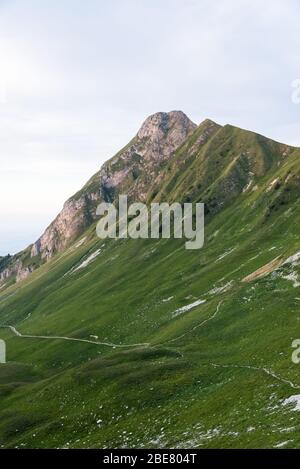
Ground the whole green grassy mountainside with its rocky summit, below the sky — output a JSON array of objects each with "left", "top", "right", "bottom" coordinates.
[{"left": 0, "top": 112, "right": 300, "bottom": 448}]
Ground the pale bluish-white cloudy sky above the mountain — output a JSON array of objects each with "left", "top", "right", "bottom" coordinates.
[{"left": 0, "top": 0, "right": 300, "bottom": 255}]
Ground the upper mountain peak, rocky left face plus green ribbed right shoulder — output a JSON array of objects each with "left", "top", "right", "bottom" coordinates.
[{"left": 0, "top": 111, "right": 294, "bottom": 284}]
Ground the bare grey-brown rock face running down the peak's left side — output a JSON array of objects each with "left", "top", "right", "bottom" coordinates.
[{"left": 0, "top": 111, "right": 197, "bottom": 283}]
